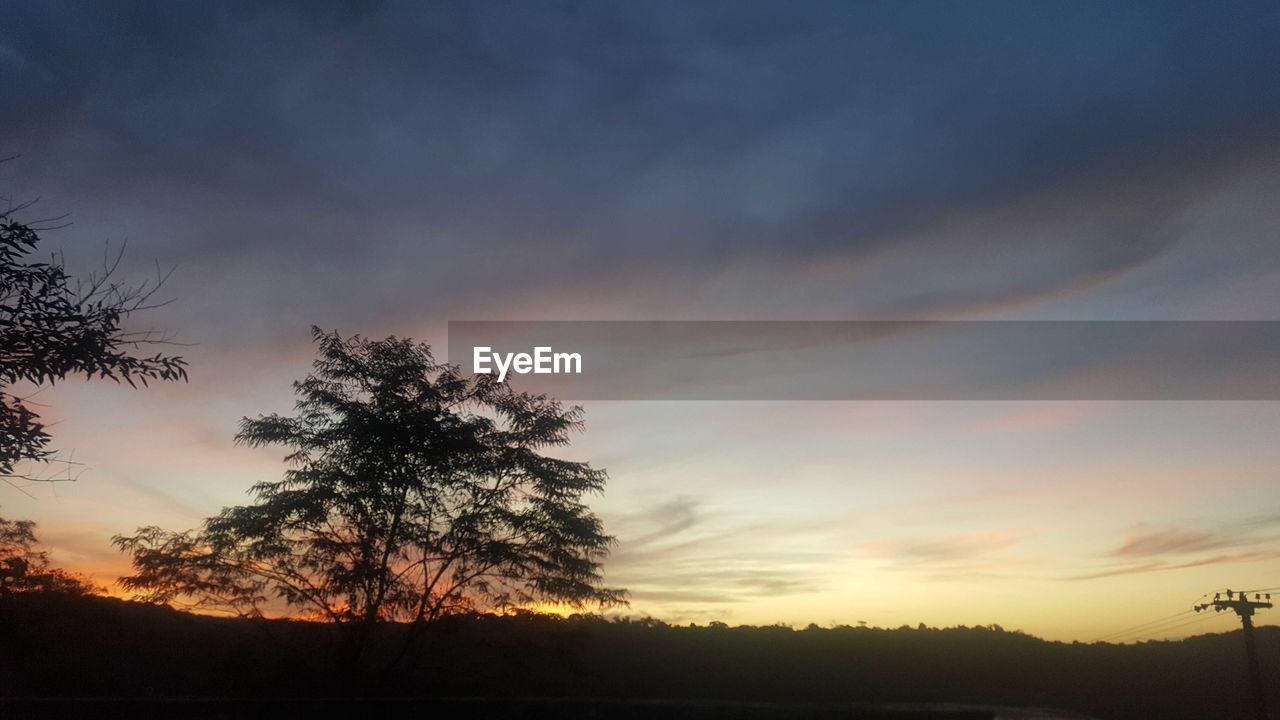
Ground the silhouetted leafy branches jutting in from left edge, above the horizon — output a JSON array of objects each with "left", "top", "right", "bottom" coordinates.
[{"left": 0, "top": 198, "right": 187, "bottom": 482}]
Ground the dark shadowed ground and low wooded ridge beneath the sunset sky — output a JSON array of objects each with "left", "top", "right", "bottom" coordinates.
[{"left": 0, "top": 597, "right": 1280, "bottom": 720}]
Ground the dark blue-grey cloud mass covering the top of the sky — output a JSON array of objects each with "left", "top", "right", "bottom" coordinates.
[{"left": 0, "top": 3, "right": 1280, "bottom": 340}]
